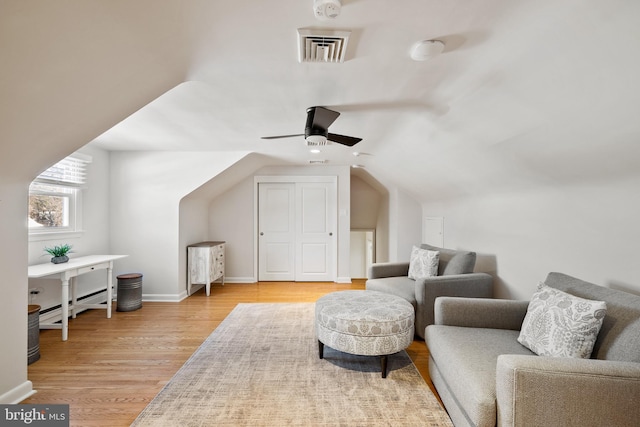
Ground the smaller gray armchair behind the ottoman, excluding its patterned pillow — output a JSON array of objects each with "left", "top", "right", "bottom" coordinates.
[{"left": 365, "top": 243, "right": 493, "bottom": 338}]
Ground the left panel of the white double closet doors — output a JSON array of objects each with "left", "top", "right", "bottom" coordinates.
[{"left": 258, "top": 183, "right": 296, "bottom": 281}]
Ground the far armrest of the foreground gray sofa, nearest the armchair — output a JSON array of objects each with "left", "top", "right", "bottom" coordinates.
[{"left": 434, "top": 297, "right": 529, "bottom": 331}]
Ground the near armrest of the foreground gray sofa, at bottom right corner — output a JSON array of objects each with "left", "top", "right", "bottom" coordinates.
[{"left": 496, "top": 355, "right": 640, "bottom": 426}]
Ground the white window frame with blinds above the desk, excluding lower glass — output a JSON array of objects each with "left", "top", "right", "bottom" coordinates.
[{"left": 29, "top": 153, "right": 91, "bottom": 241}]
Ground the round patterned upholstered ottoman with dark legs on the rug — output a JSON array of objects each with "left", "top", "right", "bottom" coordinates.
[{"left": 315, "top": 290, "right": 415, "bottom": 378}]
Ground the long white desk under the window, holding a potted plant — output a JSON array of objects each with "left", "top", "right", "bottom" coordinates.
[{"left": 29, "top": 255, "right": 127, "bottom": 341}]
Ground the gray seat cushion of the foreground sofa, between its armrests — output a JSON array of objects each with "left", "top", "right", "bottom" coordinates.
[{"left": 425, "top": 325, "right": 534, "bottom": 425}]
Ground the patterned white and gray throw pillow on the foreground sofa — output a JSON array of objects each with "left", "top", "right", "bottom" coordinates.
[{"left": 518, "top": 283, "right": 607, "bottom": 359}]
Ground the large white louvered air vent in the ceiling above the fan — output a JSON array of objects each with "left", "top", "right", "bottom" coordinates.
[{"left": 298, "top": 28, "right": 351, "bottom": 62}]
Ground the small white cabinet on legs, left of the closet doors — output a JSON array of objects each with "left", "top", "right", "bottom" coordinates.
[{"left": 187, "top": 242, "right": 225, "bottom": 296}]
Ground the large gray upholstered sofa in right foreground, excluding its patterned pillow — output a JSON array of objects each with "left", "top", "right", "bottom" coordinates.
[{"left": 425, "top": 273, "right": 640, "bottom": 427}]
